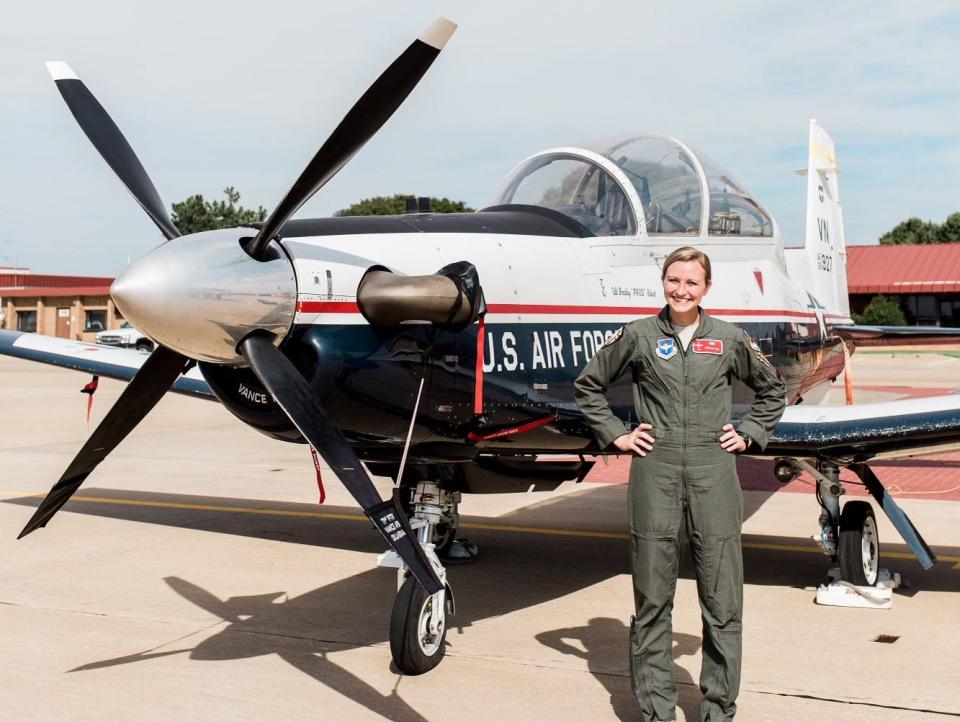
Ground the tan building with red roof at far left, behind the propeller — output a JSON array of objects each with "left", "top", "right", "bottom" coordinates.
[{"left": 0, "top": 269, "right": 123, "bottom": 342}]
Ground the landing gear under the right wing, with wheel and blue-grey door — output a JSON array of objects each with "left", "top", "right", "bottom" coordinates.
[{"left": 774, "top": 458, "right": 936, "bottom": 606}]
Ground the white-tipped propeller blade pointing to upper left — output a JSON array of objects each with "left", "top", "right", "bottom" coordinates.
[{"left": 47, "top": 61, "right": 180, "bottom": 240}]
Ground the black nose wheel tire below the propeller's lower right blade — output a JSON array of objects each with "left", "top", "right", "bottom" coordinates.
[{"left": 390, "top": 576, "right": 447, "bottom": 675}]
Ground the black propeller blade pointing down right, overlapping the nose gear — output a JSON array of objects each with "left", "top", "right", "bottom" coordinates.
[{"left": 240, "top": 335, "right": 443, "bottom": 594}]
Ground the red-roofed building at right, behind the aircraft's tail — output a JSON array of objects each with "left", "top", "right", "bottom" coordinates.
[{"left": 847, "top": 243, "right": 960, "bottom": 328}]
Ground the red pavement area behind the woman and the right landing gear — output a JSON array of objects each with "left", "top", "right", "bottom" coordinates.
[{"left": 585, "top": 452, "right": 960, "bottom": 501}]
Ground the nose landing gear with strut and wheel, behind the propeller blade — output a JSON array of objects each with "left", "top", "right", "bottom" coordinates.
[{"left": 378, "top": 482, "right": 477, "bottom": 675}]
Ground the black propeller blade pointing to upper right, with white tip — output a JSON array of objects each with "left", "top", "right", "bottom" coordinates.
[{"left": 247, "top": 18, "right": 457, "bottom": 258}]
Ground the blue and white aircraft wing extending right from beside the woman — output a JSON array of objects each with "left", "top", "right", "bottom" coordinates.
[{"left": 764, "top": 394, "right": 960, "bottom": 460}]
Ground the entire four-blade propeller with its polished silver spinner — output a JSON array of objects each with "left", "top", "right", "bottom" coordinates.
[{"left": 20, "top": 18, "right": 456, "bottom": 594}]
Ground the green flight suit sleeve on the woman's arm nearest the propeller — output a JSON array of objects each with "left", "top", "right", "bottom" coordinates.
[{"left": 573, "top": 327, "right": 637, "bottom": 449}]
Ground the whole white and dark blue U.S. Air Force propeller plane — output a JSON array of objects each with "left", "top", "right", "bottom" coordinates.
[{"left": 0, "top": 14, "right": 960, "bottom": 674}]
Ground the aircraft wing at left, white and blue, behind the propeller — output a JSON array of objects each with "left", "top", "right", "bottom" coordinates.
[{"left": 0, "top": 330, "right": 215, "bottom": 400}]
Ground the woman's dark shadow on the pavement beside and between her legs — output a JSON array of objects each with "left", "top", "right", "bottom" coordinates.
[{"left": 536, "top": 617, "right": 700, "bottom": 720}]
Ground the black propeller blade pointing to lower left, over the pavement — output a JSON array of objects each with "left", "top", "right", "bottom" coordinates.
[{"left": 17, "top": 346, "right": 189, "bottom": 539}]
